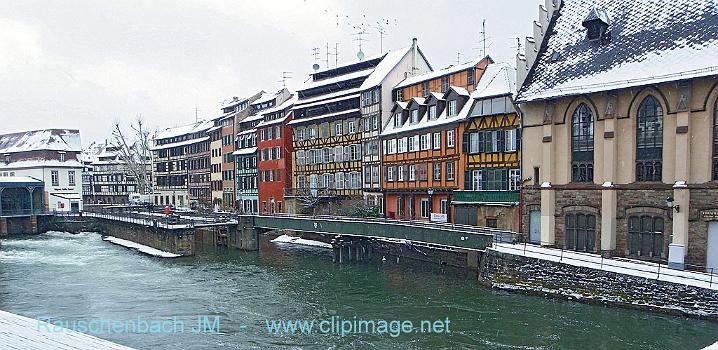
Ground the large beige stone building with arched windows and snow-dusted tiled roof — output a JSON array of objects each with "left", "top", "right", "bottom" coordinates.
[{"left": 517, "top": 0, "right": 718, "bottom": 269}]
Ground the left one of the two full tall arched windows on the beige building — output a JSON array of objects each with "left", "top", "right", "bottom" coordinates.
[{"left": 571, "top": 103, "right": 593, "bottom": 182}]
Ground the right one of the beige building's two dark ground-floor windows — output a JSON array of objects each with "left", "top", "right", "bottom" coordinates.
[{"left": 628, "top": 215, "right": 665, "bottom": 258}]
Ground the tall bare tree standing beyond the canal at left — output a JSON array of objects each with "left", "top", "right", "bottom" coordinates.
[{"left": 111, "top": 115, "right": 152, "bottom": 194}]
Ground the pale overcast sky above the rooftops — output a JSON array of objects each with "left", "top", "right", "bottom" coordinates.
[{"left": 0, "top": 0, "right": 543, "bottom": 145}]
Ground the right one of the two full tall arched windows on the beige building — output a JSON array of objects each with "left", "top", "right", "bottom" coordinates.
[{"left": 636, "top": 96, "right": 663, "bottom": 181}]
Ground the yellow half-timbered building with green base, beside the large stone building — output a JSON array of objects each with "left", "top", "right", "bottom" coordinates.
[{"left": 452, "top": 63, "right": 521, "bottom": 232}]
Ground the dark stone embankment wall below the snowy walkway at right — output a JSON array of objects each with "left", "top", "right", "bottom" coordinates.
[{"left": 479, "top": 250, "right": 718, "bottom": 320}]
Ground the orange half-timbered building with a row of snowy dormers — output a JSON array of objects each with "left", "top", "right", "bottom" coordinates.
[{"left": 381, "top": 86, "right": 471, "bottom": 222}]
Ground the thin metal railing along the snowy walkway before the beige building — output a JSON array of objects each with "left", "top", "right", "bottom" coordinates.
[{"left": 494, "top": 236, "right": 718, "bottom": 289}]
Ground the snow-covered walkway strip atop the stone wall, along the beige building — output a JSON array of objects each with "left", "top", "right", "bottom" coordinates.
[{"left": 490, "top": 243, "right": 718, "bottom": 290}]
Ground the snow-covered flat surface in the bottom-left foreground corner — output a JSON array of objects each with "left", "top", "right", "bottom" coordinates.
[{"left": 0, "top": 310, "right": 133, "bottom": 350}]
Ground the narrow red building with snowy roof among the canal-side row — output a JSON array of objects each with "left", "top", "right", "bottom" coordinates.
[{"left": 257, "top": 95, "right": 296, "bottom": 214}]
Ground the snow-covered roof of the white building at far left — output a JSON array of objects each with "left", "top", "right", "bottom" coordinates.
[{"left": 0, "top": 129, "right": 82, "bottom": 154}]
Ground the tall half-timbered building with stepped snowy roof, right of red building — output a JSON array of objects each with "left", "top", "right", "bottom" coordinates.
[{"left": 288, "top": 39, "right": 431, "bottom": 213}]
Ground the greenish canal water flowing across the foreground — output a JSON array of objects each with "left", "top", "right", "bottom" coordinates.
[{"left": 0, "top": 232, "right": 718, "bottom": 350}]
